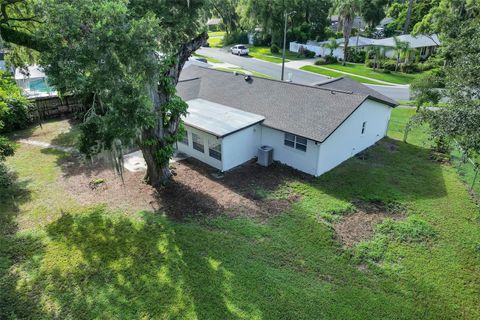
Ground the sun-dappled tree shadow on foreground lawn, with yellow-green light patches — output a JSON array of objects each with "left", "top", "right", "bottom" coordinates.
[{"left": 34, "top": 208, "right": 260, "bottom": 319}]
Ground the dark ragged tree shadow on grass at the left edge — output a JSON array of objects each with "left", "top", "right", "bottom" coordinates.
[{"left": 0, "top": 163, "right": 48, "bottom": 319}]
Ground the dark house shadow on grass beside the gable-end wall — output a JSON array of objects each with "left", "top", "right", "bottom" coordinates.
[{"left": 312, "top": 138, "right": 447, "bottom": 203}]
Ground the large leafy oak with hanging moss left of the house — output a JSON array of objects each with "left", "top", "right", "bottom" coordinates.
[{"left": 0, "top": 0, "right": 207, "bottom": 186}]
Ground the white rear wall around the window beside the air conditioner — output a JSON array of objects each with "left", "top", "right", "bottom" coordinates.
[{"left": 261, "top": 126, "right": 319, "bottom": 175}]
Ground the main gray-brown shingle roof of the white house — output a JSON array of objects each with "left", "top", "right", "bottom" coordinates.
[{"left": 177, "top": 65, "right": 396, "bottom": 142}]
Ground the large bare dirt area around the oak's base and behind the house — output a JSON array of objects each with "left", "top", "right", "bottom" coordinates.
[{"left": 57, "top": 158, "right": 303, "bottom": 219}]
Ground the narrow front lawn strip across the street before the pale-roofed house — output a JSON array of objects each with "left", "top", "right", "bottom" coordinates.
[{"left": 325, "top": 63, "right": 420, "bottom": 84}]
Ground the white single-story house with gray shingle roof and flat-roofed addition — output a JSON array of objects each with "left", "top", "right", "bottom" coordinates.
[{"left": 177, "top": 65, "right": 397, "bottom": 176}]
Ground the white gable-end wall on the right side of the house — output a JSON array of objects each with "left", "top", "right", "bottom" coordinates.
[{"left": 316, "top": 100, "right": 392, "bottom": 176}]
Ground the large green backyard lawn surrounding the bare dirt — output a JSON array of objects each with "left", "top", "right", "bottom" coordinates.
[{"left": 0, "top": 112, "right": 480, "bottom": 319}]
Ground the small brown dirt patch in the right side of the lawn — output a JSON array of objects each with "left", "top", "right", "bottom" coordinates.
[{"left": 333, "top": 201, "right": 405, "bottom": 248}]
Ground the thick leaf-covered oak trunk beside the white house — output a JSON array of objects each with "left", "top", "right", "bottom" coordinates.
[{"left": 140, "top": 33, "right": 208, "bottom": 187}]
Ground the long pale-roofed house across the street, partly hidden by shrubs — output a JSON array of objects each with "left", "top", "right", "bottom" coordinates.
[{"left": 289, "top": 34, "right": 441, "bottom": 59}]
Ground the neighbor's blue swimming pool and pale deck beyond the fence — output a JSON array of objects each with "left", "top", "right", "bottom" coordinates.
[{"left": 15, "top": 65, "right": 56, "bottom": 97}]
